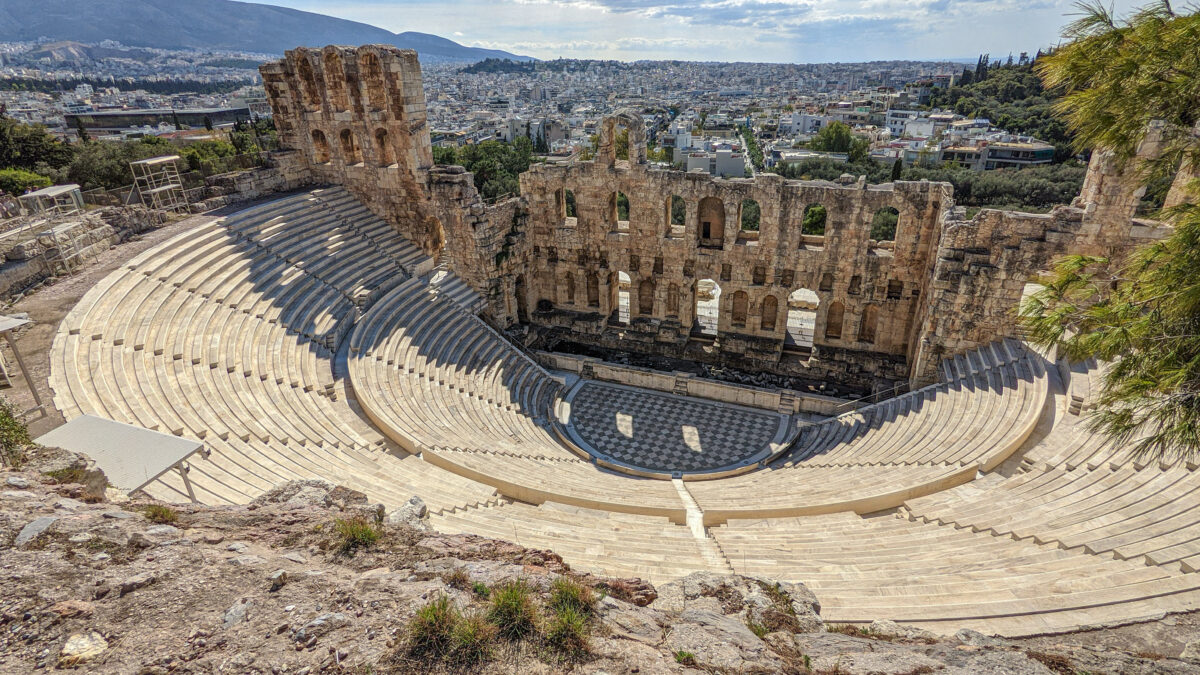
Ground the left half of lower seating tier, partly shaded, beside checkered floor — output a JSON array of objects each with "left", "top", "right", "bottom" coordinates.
[{"left": 348, "top": 281, "right": 685, "bottom": 522}]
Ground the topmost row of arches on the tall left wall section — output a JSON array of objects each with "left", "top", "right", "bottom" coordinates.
[{"left": 296, "top": 50, "right": 404, "bottom": 118}]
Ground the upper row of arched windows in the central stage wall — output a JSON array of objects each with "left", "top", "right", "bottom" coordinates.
[{"left": 554, "top": 189, "right": 900, "bottom": 242}]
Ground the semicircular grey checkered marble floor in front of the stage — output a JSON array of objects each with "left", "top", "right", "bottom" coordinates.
[{"left": 569, "top": 381, "right": 782, "bottom": 473}]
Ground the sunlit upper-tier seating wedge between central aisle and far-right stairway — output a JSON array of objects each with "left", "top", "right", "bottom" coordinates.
[{"left": 713, "top": 513, "right": 1200, "bottom": 635}]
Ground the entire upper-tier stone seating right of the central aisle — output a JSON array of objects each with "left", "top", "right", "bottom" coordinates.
[{"left": 712, "top": 365, "right": 1200, "bottom": 635}]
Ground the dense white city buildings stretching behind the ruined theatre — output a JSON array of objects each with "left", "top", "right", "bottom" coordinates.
[{"left": 0, "top": 36, "right": 1081, "bottom": 210}]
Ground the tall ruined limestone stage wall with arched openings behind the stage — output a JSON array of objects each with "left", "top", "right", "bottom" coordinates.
[{"left": 260, "top": 46, "right": 1190, "bottom": 388}]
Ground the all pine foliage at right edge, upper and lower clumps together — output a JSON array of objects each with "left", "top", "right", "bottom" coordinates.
[{"left": 1021, "top": 2, "right": 1200, "bottom": 459}]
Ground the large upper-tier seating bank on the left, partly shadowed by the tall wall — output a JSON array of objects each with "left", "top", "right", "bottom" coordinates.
[{"left": 52, "top": 186, "right": 496, "bottom": 509}]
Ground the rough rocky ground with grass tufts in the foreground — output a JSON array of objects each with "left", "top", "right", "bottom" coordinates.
[{"left": 0, "top": 450, "right": 1200, "bottom": 675}]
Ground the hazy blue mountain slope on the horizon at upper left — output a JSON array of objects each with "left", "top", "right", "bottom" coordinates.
[{"left": 0, "top": 0, "right": 533, "bottom": 62}]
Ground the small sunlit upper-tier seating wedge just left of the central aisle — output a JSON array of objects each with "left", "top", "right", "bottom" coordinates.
[{"left": 432, "top": 500, "right": 713, "bottom": 583}]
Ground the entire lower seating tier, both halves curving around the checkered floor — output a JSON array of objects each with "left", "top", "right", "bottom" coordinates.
[{"left": 348, "top": 285, "right": 1046, "bottom": 524}]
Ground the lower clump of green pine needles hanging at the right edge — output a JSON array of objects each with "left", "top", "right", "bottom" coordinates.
[{"left": 1020, "top": 196, "right": 1200, "bottom": 461}]
